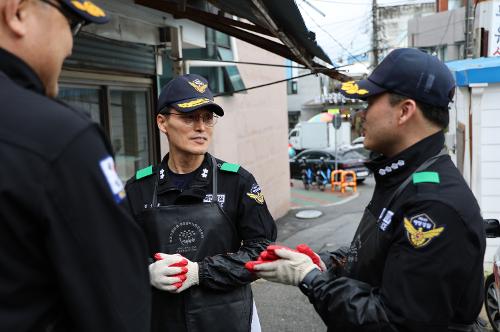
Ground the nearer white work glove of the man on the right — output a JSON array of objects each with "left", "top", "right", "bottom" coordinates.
[{"left": 254, "top": 249, "right": 319, "bottom": 286}]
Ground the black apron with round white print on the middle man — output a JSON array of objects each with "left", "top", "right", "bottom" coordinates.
[{"left": 140, "top": 157, "right": 252, "bottom": 332}]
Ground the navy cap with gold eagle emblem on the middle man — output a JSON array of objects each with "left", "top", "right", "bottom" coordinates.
[{"left": 156, "top": 74, "right": 224, "bottom": 116}]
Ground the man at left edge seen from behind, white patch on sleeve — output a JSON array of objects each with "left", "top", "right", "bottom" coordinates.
[{"left": 0, "top": 0, "right": 150, "bottom": 332}]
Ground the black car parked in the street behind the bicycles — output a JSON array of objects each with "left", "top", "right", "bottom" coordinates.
[{"left": 289, "top": 148, "right": 370, "bottom": 182}]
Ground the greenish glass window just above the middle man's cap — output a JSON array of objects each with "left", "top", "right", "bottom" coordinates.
[{"left": 183, "top": 27, "right": 245, "bottom": 93}]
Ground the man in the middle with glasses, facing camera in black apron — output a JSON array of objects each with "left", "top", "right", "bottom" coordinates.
[{"left": 126, "top": 74, "right": 276, "bottom": 332}]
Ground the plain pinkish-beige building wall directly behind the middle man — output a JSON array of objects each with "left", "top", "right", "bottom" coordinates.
[{"left": 211, "top": 40, "right": 290, "bottom": 218}]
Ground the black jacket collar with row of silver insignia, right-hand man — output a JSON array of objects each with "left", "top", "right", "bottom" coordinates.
[{"left": 366, "top": 131, "right": 444, "bottom": 187}]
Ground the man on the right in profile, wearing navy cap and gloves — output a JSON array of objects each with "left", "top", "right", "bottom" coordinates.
[{"left": 255, "top": 49, "right": 485, "bottom": 332}]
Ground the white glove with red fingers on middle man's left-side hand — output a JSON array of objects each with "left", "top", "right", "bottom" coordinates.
[{"left": 149, "top": 253, "right": 188, "bottom": 293}]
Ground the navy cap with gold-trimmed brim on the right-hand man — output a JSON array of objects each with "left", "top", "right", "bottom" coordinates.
[{"left": 340, "top": 48, "right": 455, "bottom": 107}]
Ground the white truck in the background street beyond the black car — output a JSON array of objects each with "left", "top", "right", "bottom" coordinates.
[{"left": 288, "top": 122, "right": 351, "bottom": 152}]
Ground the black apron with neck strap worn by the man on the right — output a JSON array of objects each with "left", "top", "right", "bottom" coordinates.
[{"left": 342, "top": 150, "right": 473, "bottom": 331}]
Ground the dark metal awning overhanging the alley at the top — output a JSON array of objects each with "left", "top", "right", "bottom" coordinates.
[{"left": 135, "top": 0, "right": 349, "bottom": 81}]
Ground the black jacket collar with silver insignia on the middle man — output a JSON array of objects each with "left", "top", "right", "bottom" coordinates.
[{"left": 158, "top": 152, "right": 213, "bottom": 198}]
